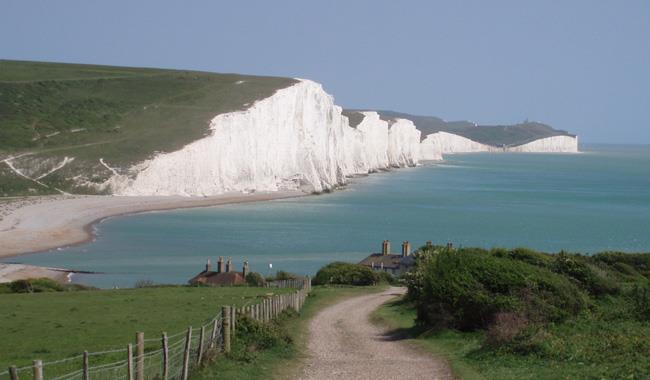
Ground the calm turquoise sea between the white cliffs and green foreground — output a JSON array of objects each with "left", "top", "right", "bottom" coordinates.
[{"left": 5, "top": 146, "right": 650, "bottom": 287}]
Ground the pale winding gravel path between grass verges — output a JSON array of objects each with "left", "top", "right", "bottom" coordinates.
[{"left": 302, "top": 288, "right": 453, "bottom": 380}]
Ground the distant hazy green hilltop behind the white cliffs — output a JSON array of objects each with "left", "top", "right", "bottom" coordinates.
[{"left": 344, "top": 110, "right": 573, "bottom": 146}]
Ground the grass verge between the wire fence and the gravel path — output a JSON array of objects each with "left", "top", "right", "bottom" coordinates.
[{"left": 191, "top": 286, "right": 385, "bottom": 380}]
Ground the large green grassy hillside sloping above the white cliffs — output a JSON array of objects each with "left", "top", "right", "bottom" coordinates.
[{"left": 0, "top": 60, "right": 295, "bottom": 196}]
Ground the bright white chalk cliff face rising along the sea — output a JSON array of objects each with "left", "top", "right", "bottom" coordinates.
[{"left": 110, "top": 80, "right": 577, "bottom": 196}]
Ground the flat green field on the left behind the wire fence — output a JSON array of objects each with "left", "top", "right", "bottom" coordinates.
[{"left": 0, "top": 286, "right": 292, "bottom": 369}]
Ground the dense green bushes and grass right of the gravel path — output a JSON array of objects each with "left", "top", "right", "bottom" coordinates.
[{"left": 375, "top": 246, "right": 650, "bottom": 379}]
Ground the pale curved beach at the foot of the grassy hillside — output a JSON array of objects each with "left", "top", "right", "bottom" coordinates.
[{"left": 0, "top": 192, "right": 305, "bottom": 268}]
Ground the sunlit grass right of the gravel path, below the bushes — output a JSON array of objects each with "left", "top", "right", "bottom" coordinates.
[{"left": 373, "top": 301, "right": 650, "bottom": 380}]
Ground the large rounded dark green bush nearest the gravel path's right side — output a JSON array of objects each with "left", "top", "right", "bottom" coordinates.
[{"left": 412, "top": 248, "right": 588, "bottom": 331}]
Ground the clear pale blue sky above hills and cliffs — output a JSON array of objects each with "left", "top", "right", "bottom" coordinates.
[{"left": 0, "top": 0, "right": 650, "bottom": 144}]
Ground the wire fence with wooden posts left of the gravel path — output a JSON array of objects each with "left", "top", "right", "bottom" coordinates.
[{"left": 0, "top": 277, "right": 311, "bottom": 380}]
